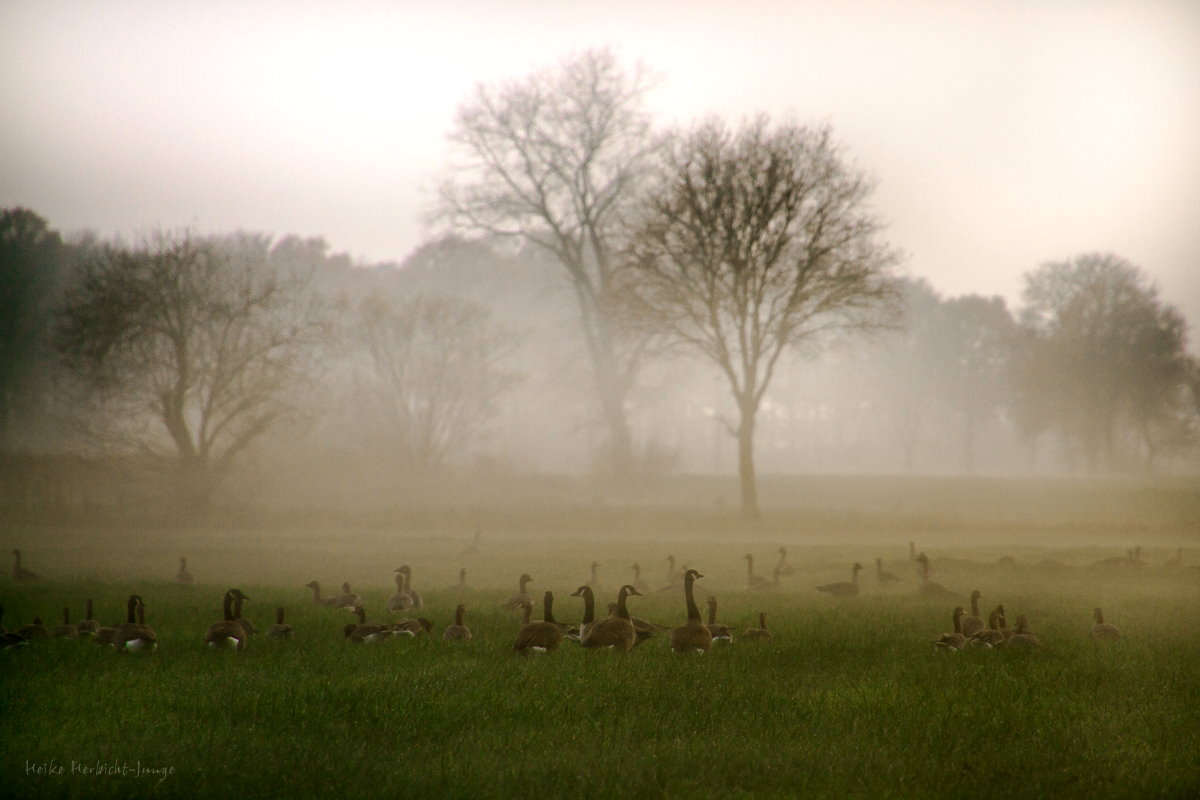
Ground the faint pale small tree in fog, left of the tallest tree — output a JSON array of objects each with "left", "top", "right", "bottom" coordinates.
[{"left": 359, "top": 293, "right": 516, "bottom": 468}]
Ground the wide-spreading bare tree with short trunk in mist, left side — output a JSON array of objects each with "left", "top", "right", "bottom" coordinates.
[{"left": 56, "top": 234, "right": 328, "bottom": 513}]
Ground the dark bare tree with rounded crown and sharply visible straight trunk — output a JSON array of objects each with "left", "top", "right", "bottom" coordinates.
[{"left": 624, "top": 118, "right": 896, "bottom": 518}]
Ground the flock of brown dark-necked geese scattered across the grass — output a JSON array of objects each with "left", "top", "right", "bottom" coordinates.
[{"left": 0, "top": 544, "right": 1156, "bottom": 652}]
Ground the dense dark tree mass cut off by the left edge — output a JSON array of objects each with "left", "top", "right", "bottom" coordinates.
[{"left": 0, "top": 209, "right": 68, "bottom": 450}]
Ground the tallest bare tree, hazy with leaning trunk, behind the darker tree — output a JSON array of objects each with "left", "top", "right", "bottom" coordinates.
[{"left": 438, "top": 50, "right": 652, "bottom": 474}]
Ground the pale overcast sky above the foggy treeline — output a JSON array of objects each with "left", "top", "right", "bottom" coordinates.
[{"left": 7, "top": 0, "right": 1200, "bottom": 342}]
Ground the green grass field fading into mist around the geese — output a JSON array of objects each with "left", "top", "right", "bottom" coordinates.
[{"left": 0, "top": 479, "right": 1200, "bottom": 798}]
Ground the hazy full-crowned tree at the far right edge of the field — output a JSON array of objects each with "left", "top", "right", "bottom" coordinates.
[{"left": 1014, "top": 253, "right": 1193, "bottom": 471}]
